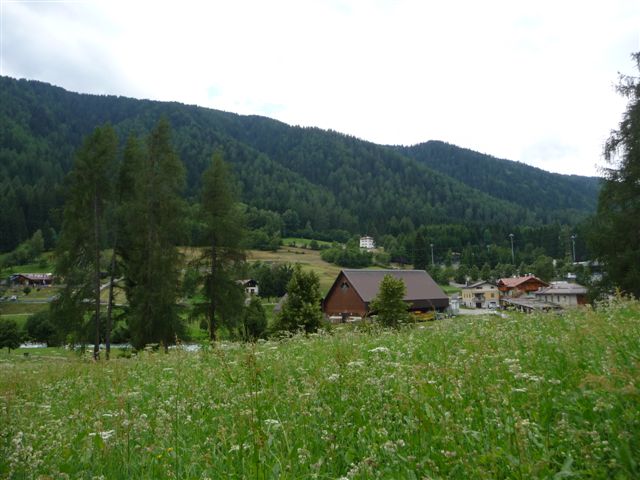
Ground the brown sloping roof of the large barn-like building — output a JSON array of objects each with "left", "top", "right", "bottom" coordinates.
[{"left": 342, "top": 270, "right": 449, "bottom": 307}]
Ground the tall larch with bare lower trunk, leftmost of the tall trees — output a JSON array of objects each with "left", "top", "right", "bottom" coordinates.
[{"left": 52, "top": 125, "right": 118, "bottom": 359}]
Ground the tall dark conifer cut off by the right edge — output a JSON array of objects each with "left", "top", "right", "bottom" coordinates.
[{"left": 590, "top": 53, "right": 640, "bottom": 297}]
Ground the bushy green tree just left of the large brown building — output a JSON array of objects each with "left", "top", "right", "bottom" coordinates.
[{"left": 276, "top": 265, "right": 322, "bottom": 333}]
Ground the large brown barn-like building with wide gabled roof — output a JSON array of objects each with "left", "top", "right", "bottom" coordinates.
[{"left": 322, "top": 270, "right": 449, "bottom": 318}]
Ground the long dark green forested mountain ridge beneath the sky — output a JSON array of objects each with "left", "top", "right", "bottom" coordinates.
[{"left": 0, "top": 77, "right": 598, "bottom": 251}]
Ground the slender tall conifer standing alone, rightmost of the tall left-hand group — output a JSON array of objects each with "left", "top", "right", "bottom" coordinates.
[{"left": 199, "top": 151, "right": 244, "bottom": 340}]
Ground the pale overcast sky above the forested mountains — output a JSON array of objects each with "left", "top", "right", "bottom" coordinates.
[{"left": 0, "top": 0, "right": 640, "bottom": 175}]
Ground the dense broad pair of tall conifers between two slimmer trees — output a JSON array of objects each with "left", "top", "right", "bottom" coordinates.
[{"left": 119, "top": 119, "right": 185, "bottom": 348}]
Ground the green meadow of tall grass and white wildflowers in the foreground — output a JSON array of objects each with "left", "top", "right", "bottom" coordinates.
[{"left": 0, "top": 300, "right": 640, "bottom": 479}]
